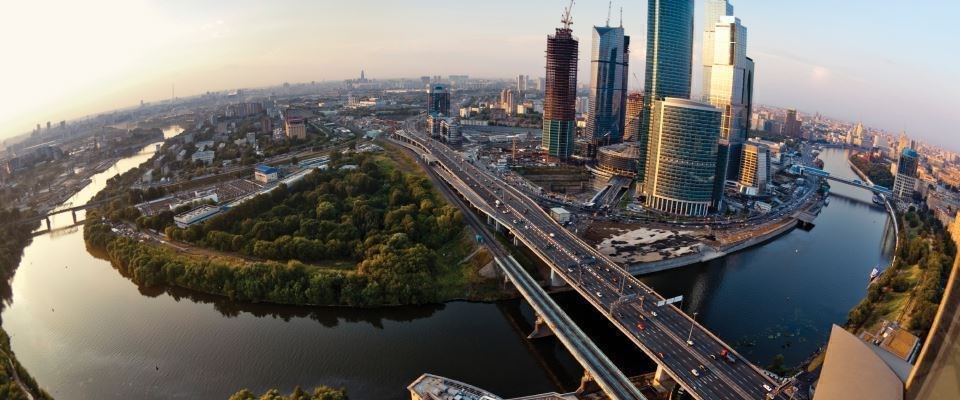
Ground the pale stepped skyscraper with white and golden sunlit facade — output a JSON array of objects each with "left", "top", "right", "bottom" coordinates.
[{"left": 703, "top": 12, "right": 753, "bottom": 179}]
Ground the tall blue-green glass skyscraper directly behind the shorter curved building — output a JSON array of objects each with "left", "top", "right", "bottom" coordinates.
[{"left": 637, "top": 0, "right": 692, "bottom": 179}]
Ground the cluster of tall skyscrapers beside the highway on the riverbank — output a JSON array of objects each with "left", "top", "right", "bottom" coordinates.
[{"left": 543, "top": 0, "right": 752, "bottom": 216}]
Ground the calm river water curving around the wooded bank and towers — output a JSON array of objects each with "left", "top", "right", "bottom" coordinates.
[{"left": 3, "top": 143, "right": 892, "bottom": 399}]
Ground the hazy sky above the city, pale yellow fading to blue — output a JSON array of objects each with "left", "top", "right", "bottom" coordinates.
[{"left": 0, "top": 0, "right": 960, "bottom": 150}]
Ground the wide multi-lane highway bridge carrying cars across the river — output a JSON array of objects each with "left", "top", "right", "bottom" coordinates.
[{"left": 393, "top": 130, "right": 786, "bottom": 399}]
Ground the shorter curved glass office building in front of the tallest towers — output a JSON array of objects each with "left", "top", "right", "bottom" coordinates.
[{"left": 643, "top": 97, "right": 721, "bottom": 216}]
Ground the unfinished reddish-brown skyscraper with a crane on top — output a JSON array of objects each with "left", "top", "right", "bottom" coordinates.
[{"left": 542, "top": 8, "right": 579, "bottom": 160}]
